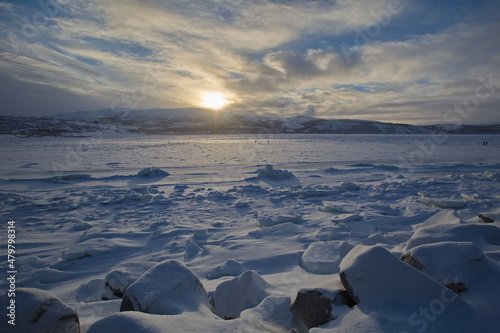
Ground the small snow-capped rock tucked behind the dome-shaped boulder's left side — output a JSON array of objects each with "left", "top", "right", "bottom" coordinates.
[{"left": 102, "top": 261, "right": 156, "bottom": 299}]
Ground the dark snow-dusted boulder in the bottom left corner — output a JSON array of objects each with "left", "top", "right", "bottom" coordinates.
[{"left": 0, "top": 288, "right": 80, "bottom": 333}]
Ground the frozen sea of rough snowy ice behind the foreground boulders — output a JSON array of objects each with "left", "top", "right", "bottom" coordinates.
[{"left": 0, "top": 135, "right": 500, "bottom": 333}]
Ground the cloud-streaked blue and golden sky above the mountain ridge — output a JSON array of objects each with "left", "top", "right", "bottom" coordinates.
[{"left": 0, "top": 0, "right": 500, "bottom": 125}]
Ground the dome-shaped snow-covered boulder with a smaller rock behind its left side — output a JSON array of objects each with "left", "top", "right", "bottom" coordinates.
[{"left": 120, "top": 260, "right": 211, "bottom": 315}]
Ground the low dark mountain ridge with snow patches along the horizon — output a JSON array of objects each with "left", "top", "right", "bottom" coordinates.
[{"left": 0, "top": 108, "right": 500, "bottom": 136}]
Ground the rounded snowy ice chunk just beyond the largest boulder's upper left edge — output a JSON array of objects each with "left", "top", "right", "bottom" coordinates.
[{"left": 301, "top": 240, "right": 354, "bottom": 274}]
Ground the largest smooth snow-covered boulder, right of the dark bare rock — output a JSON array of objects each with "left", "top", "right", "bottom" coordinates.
[{"left": 316, "top": 245, "right": 476, "bottom": 333}]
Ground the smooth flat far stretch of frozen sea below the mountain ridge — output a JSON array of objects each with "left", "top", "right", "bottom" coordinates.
[{"left": 0, "top": 134, "right": 500, "bottom": 182}]
